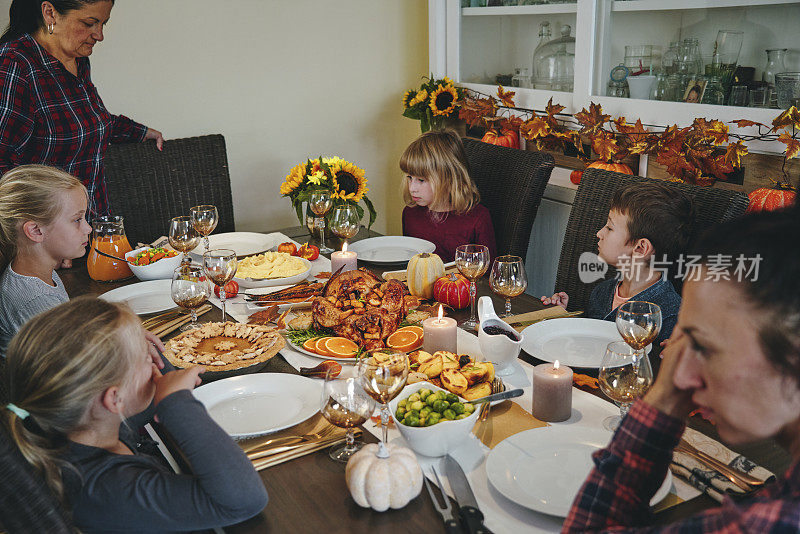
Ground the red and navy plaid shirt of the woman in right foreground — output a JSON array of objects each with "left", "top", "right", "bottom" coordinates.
[{"left": 562, "top": 401, "right": 800, "bottom": 533}]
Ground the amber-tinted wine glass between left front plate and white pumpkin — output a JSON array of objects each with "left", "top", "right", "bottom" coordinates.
[{"left": 320, "top": 367, "right": 375, "bottom": 462}]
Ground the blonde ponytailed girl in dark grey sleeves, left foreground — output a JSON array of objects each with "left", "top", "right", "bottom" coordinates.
[{"left": 0, "top": 296, "right": 267, "bottom": 532}]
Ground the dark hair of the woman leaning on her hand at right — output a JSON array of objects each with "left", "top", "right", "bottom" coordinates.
[{"left": 694, "top": 206, "right": 800, "bottom": 383}]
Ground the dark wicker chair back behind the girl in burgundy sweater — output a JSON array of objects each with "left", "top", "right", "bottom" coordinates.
[{"left": 464, "top": 138, "right": 554, "bottom": 259}]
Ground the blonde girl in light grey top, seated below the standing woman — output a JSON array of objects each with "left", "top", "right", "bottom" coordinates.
[{"left": 0, "top": 165, "right": 91, "bottom": 354}]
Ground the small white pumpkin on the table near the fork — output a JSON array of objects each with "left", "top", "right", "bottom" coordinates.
[{"left": 344, "top": 443, "right": 422, "bottom": 512}]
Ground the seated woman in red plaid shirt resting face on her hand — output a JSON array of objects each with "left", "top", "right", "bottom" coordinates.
[{"left": 563, "top": 206, "right": 800, "bottom": 533}]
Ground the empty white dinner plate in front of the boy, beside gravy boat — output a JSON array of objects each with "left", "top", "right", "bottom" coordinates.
[{"left": 522, "top": 317, "right": 650, "bottom": 369}]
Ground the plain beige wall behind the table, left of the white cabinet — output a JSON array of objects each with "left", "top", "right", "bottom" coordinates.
[{"left": 0, "top": 0, "right": 428, "bottom": 233}]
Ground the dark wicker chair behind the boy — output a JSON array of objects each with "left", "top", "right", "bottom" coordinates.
[{"left": 555, "top": 169, "right": 747, "bottom": 310}]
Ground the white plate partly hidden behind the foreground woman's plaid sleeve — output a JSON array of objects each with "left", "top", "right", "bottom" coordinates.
[{"left": 486, "top": 425, "right": 672, "bottom": 517}]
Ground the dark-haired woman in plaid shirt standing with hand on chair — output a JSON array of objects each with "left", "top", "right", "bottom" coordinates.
[{"left": 0, "top": 0, "right": 164, "bottom": 217}]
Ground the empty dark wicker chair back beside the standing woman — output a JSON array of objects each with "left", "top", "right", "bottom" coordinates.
[{"left": 105, "top": 135, "right": 234, "bottom": 249}]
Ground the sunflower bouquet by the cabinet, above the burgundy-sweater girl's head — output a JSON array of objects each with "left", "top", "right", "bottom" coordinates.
[{"left": 403, "top": 75, "right": 464, "bottom": 133}]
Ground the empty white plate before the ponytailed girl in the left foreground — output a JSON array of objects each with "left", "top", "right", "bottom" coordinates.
[{"left": 194, "top": 373, "right": 322, "bottom": 439}]
